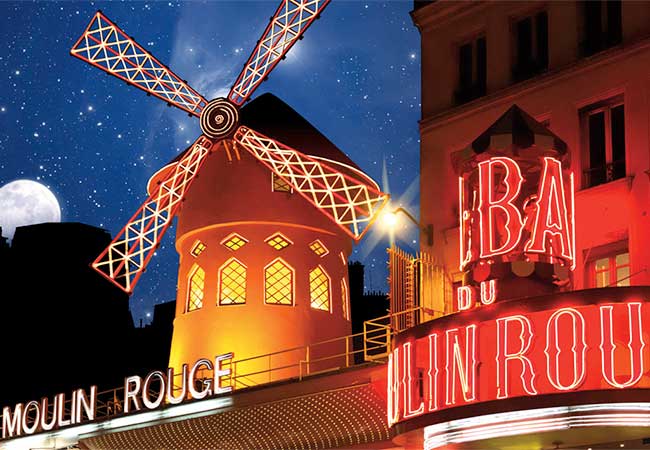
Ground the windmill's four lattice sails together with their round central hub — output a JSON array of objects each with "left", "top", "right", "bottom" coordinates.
[{"left": 71, "top": 0, "right": 388, "bottom": 293}]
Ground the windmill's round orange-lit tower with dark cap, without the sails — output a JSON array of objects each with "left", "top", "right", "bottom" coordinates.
[{"left": 162, "top": 94, "right": 373, "bottom": 376}]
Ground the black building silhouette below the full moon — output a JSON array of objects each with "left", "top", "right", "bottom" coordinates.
[{"left": 0, "top": 223, "right": 171, "bottom": 406}]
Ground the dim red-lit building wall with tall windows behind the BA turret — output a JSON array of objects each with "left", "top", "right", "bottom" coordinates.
[{"left": 412, "top": 1, "right": 650, "bottom": 289}]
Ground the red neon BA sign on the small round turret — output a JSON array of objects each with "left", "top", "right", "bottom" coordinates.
[{"left": 458, "top": 156, "right": 575, "bottom": 270}]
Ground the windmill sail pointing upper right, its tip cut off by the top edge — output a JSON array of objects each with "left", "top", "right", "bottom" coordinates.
[{"left": 228, "top": 0, "right": 330, "bottom": 105}]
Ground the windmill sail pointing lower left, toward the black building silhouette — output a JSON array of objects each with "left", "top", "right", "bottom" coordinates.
[{"left": 92, "top": 136, "right": 215, "bottom": 293}]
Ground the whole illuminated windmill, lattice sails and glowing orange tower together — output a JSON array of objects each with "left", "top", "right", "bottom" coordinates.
[{"left": 71, "top": 0, "right": 387, "bottom": 374}]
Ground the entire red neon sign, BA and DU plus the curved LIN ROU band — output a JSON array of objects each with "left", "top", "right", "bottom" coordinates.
[{"left": 387, "top": 156, "right": 650, "bottom": 425}]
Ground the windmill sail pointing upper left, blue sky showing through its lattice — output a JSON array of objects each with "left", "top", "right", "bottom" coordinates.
[{"left": 70, "top": 11, "right": 207, "bottom": 117}]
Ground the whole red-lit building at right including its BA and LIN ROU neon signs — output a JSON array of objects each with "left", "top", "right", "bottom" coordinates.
[{"left": 387, "top": 1, "right": 650, "bottom": 449}]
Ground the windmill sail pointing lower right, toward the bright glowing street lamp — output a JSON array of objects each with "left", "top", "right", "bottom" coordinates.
[{"left": 233, "top": 127, "right": 388, "bottom": 241}]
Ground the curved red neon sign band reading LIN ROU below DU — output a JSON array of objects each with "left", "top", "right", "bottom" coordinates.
[{"left": 387, "top": 294, "right": 650, "bottom": 425}]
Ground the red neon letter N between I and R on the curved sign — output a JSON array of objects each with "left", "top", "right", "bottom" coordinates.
[{"left": 445, "top": 325, "right": 476, "bottom": 405}]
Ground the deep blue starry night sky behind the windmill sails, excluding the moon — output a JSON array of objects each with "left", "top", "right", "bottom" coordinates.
[{"left": 0, "top": 0, "right": 420, "bottom": 321}]
